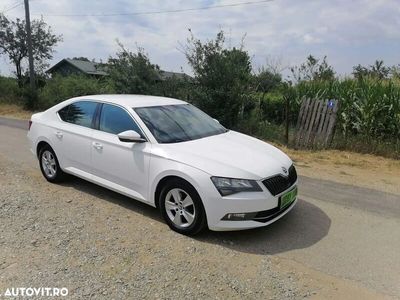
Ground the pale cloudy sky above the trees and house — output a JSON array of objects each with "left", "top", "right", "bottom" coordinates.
[{"left": 0, "top": 0, "right": 400, "bottom": 75}]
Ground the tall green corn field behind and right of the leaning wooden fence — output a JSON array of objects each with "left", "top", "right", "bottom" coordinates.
[{"left": 288, "top": 79, "right": 400, "bottom": 140}]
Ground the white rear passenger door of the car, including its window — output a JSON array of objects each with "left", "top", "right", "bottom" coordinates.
[{"left": 53, "top": 101, "right": 98, "bottom": 178}]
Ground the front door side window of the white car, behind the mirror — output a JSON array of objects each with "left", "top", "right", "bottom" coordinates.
[{"left": 99, "top": 104, "right": 143, "bottom": 136}]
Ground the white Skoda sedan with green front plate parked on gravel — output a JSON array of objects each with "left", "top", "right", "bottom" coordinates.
[{"left": 28, "top": 95, "right": 297, "bottom": 235}]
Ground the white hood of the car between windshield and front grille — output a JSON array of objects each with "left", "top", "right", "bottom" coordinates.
[{"left": 154, "top": 131, "right": 292, "bottom": 180}]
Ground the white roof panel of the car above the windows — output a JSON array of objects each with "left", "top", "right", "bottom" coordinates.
[{"left": 70, "top": 94, "right": 187, "bottom": 107}]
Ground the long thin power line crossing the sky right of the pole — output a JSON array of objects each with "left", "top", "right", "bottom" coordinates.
[{"left": 33, "top": 0, "right": 274, "bottom": 17}]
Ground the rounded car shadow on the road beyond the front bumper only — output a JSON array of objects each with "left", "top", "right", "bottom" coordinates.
[{"left": 196, "top": 199, "right": 331, "bottom": 254}]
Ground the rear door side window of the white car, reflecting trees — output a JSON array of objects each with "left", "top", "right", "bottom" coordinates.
[{"left": 58, "top": 101, "right": 97, "bottom": 128}]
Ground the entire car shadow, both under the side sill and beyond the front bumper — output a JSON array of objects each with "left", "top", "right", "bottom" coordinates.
[{"left": 62, "top": 177, "right": 331, "bottom": 254}]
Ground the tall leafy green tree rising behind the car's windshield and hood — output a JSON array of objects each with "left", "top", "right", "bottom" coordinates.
[{"left": 182, "top": 30, "right": 251, "bottom": 127}]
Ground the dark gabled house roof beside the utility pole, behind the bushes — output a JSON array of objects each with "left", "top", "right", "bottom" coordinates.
[{"left": 46, "top": 58, "right": 107, "bottom": 77}]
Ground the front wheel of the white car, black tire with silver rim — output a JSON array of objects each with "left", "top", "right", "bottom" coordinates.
[{"left": 159, "top": 179, "right": 207, "bottom": 235}]
